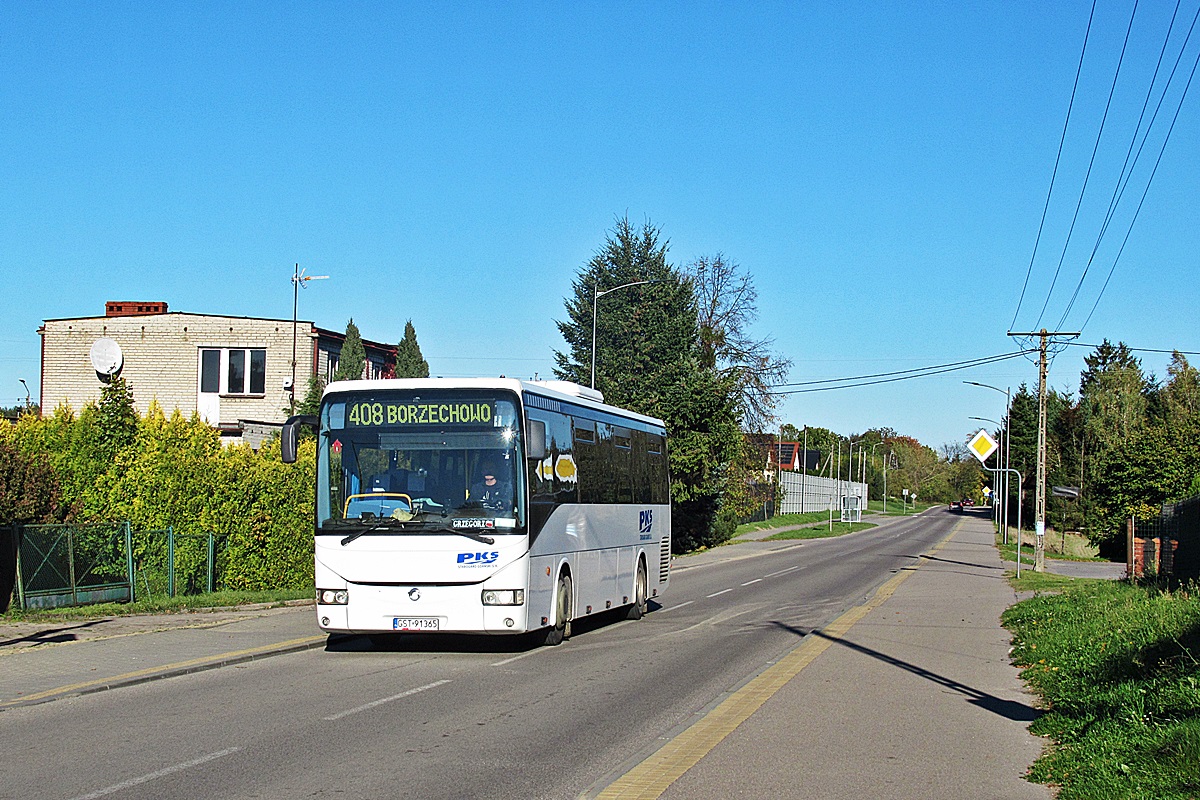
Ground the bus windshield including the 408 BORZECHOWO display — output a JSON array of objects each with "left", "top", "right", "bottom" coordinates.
[{"left": 317, "top": 390, "right": 524, "bottom": 533}]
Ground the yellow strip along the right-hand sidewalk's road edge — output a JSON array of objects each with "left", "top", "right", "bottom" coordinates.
[{"left": 595, "top": 522, "right": 962, "bottom": 800}]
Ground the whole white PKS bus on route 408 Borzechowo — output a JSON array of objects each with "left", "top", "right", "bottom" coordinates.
[{"left": 282, "top": 378, "right": 671, "bottom": 644}]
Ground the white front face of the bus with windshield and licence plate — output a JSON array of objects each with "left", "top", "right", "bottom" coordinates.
[{"left": 316, "top": 380, "right": 536, "bottom": 633}]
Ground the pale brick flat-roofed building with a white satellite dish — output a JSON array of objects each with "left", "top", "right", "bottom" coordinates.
[{"left": 38, "top": 301, "right": 396, "bottom": 447}]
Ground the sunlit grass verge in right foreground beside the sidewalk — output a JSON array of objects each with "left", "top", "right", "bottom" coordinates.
[{"left": 1003, "top": 572, "right": 1200, "bottom": 800}]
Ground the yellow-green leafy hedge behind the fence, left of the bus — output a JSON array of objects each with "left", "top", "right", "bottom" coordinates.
[{"left": 0, "top": 405, "right": 316, "bottom": 590}]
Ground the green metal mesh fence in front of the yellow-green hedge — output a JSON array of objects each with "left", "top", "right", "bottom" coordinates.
[{"left": 14, "top": 522, "right": 228, "bottom": 608}]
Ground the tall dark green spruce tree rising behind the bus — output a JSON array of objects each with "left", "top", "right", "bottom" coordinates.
[{"left": 554, "top": 217, "right": 743, "bottom": 552}]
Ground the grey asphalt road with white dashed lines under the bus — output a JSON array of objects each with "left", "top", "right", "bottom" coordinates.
[{"left": 0, "top": 515, "right": 958, "bottom": 800}]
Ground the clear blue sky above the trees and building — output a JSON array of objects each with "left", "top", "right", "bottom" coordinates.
[{"left": 0, "top": 0, "right": 1200, "bottom": 447}]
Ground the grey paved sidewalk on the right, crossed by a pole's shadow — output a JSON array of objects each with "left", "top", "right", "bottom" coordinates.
[{"left": 609, "top": 517, "right": 1052, "bottom": 800}]
